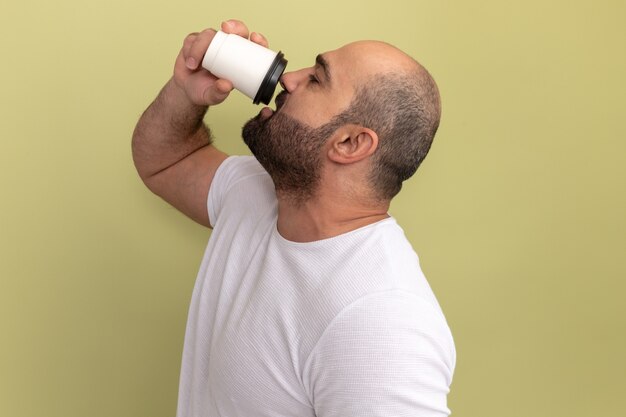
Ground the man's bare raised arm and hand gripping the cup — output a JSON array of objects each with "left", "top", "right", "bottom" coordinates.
[{"left": 132, "top": 20, "right": 267, "bottom": 227}]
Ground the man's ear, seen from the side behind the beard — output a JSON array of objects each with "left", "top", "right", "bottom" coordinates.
[{"left": 328, "top": 125, "right": 378, "bottom": 164}]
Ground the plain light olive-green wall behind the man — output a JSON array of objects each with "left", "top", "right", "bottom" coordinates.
[{"left": 0, "top": 0, "right": 626, "bottom": 417}]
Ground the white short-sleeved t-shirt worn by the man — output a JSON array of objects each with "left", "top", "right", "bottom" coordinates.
[{"left": 177, "top": 156, "right": 455, "bottom": 417}]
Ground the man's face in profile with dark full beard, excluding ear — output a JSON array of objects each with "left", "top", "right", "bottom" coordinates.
[{"left": 242, "top": 50, "right": 352, "bottom": 198}]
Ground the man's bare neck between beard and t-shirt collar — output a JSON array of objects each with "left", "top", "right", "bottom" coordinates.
[{"left": 278, "top": 188, "right": 389, "bottom": 242}]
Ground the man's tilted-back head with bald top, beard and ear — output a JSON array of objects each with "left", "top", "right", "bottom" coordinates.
[{"left": 243, "top": 41, "right": 440, "bottom": 201}]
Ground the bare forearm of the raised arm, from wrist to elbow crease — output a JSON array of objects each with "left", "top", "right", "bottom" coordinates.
[{"left": 132, "top": 79, "right": 211, "bottom": 182}]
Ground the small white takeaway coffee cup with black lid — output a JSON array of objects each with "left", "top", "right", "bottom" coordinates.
[{"left": 202, "top": 31, "right": 287, "bottom": 104}]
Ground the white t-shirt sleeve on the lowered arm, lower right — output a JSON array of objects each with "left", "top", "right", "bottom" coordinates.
[{"left": 304, "top": 290, "right": 456, "bottom": 417}]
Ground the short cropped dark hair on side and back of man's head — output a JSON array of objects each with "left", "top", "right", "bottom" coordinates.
[{"left": 337, "top": 64, "right": 441, "bottom": 200}]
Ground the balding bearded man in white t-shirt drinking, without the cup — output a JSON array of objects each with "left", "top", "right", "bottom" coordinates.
[{"left": 133, "top": 20, "right": 456, "bottom": 417}]
